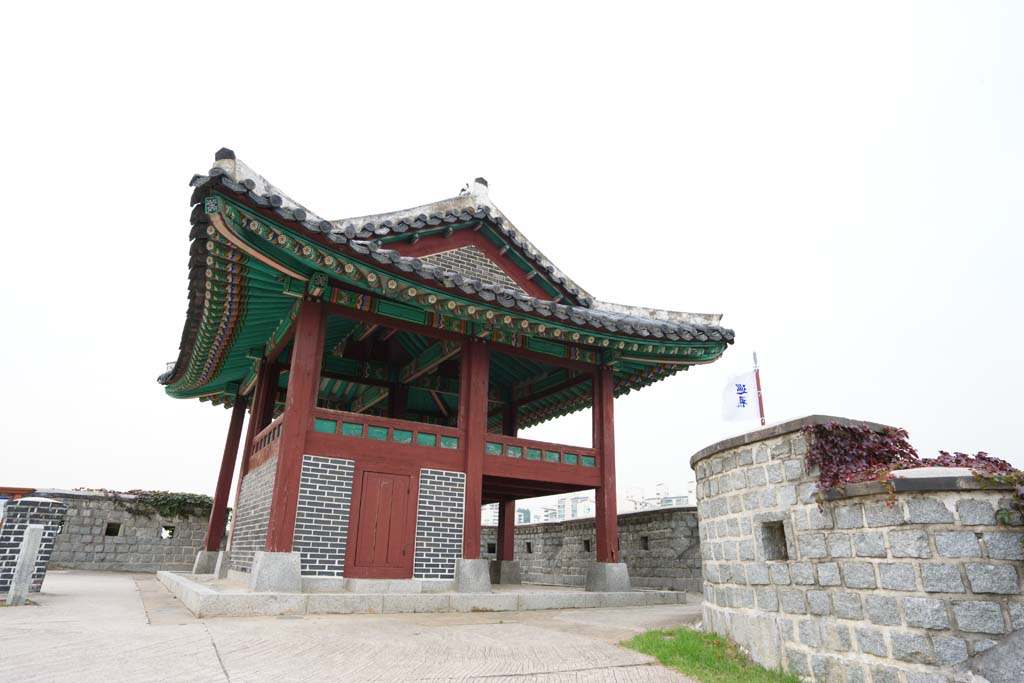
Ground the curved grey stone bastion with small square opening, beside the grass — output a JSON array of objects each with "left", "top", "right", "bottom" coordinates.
[{"left": 690, "top": 416, "right": 1024, "bottom": 683}]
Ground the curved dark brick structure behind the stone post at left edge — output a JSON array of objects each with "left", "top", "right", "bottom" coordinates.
[{"left": 0, "top": 497, "right": 68, "bottom": 593}]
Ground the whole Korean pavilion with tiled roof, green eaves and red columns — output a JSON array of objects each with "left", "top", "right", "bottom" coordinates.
[{"left": 160, "top": 150, "right": 733, "bottom": 591}]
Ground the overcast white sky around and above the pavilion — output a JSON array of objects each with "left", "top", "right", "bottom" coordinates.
[{"left": 0, "top": 2, "right": 1024, "bottom": 507}]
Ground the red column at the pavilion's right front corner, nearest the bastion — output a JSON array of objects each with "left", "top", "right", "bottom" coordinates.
[{"left": 593, "top": 368, "right": 618, "bottom": 562}]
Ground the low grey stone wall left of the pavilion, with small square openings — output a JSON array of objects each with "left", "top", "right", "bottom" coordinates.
[{"left": 37, "top": 490, "right": 208, "bottom": 571}]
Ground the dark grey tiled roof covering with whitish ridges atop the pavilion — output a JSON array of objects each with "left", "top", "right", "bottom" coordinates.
[{"left": 191, "top": 150, "right": 734, "bottom": 344}]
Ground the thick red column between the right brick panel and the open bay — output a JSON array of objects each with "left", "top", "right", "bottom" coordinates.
[{"left": 459, "top": 339, "right": 490, "bottom": 560}]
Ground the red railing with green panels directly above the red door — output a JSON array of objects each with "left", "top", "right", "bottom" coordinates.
[{"left": 305, "top": 408, "right": 462, "bottom": 451}]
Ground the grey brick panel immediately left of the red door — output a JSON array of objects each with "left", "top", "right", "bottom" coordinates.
[{"left": 293, "top": 456, "right": 355, "bottom": 577}]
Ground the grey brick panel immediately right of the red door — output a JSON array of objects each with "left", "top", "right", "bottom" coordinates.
[{"left": 413, "top": 469, "right": 466, "bottom": 579}]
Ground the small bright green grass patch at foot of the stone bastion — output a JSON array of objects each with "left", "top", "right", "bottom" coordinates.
[{"left": 623, "top": 629, "right": 800, "bottom": 683}]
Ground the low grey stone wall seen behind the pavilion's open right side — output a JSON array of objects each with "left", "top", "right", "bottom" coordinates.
[{"left": 480, "top": 508, "right": 701, "bottom": 592}]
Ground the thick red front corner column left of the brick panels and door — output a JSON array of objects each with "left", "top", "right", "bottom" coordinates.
[{"left": 265, "top": 300, "right": 327, "bottom": 553}]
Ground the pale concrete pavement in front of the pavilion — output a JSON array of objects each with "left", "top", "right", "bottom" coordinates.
[{"left": 0, "top": 570, "right": 699, "bottom": 683}]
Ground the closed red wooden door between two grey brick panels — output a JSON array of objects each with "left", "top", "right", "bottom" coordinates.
[{"left": 354, "top": 472, "right": 413, "bottom": 579}]
